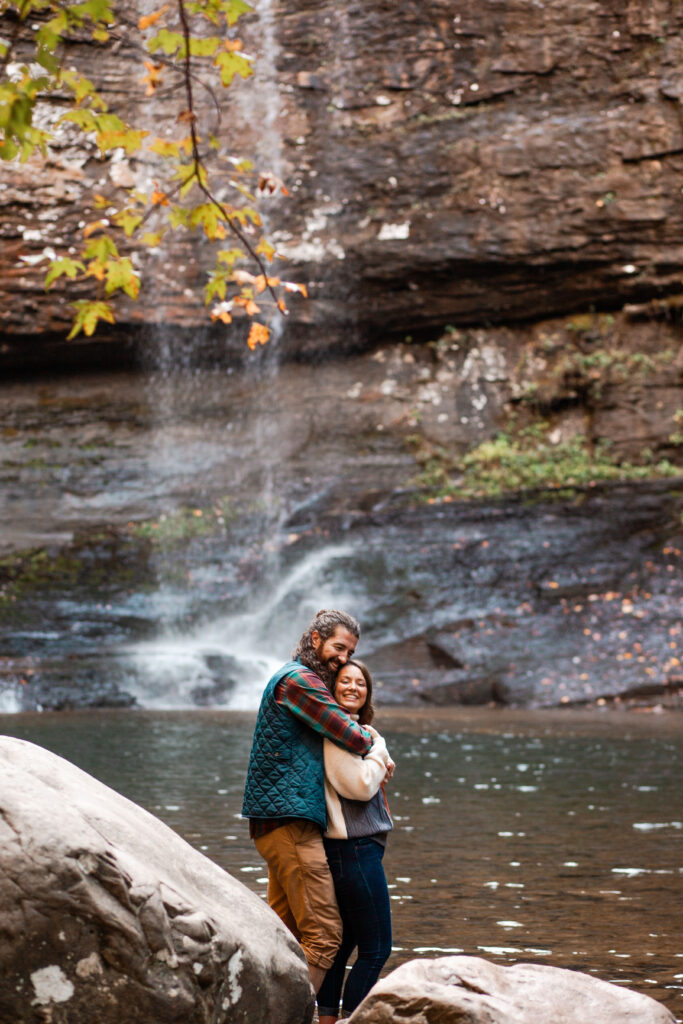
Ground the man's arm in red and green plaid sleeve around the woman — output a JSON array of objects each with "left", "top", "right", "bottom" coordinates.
[{"left": 274, "top": 666, "right": 373, "bottom": 756}]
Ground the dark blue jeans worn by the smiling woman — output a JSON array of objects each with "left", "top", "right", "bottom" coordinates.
[{"left": 317, "top": 839, "right": 391, "bottom": 1017}]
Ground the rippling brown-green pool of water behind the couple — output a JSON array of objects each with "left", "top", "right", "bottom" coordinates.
[{"left": 0, "top": 710, "right": 683, "bottom": 1019}]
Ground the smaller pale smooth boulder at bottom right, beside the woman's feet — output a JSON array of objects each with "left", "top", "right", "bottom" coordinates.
[{"left": 350, "top": 956, "right": 674, "bottom": 1024}]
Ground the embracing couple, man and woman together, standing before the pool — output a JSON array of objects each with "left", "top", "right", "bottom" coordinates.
[{"left": 242, "top": 610, "right": 394, "bottom": 1024}]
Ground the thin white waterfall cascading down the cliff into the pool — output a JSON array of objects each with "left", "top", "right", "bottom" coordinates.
[{"left": 125, "top": 0, "right": 349, "bottom": 709}]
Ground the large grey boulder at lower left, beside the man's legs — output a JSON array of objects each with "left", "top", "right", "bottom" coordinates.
[{"left": 0, "top": 736, "right": 312, "bottom": 1024}]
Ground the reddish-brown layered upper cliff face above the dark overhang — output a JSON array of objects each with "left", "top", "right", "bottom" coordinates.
[{"left": 0, "top": 0, "right": 683, "bottom": 365}]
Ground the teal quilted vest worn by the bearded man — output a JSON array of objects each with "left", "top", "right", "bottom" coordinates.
[{"left": 242, "top": 662, "right": 328, "bottom": 830}]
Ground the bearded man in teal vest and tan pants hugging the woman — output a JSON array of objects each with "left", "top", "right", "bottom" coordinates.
[{"left": 242, "top": 610, "right": 373, "bottom": 993}]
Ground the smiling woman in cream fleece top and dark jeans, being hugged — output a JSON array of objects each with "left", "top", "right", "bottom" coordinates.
[{"left": 317, "top": 658, "right": 394, "bottom": 1024}]
